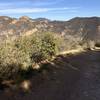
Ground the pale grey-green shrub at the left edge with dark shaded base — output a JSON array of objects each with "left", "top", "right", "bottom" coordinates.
[{"left": 0, "top": 39, "right": 30, "bottom": 79}]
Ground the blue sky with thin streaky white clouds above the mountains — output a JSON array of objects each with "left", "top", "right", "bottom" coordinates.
[{"left": 0, "top": 0, "right": 100, "bottom": 20}]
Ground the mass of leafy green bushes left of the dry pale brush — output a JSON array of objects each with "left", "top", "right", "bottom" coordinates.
[{"left": 0, "top": 33, "right": 58, "bottom": 79}]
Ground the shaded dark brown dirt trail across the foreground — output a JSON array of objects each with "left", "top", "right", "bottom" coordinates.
[{"left": 0, "top": 50, "right": 100, "bottom": 100}]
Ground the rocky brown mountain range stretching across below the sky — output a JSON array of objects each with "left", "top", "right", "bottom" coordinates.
[{"left": 0, "top": 16, "right": 100, "bottom": 46}]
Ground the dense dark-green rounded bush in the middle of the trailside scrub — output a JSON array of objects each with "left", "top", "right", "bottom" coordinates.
[{"left": 32, "top": 33, "right": 57, "bottom": 63}]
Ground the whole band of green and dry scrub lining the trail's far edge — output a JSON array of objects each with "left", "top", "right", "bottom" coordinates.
[{"left": 0, "top": 32, "right": 94, "bottom": 79}]
